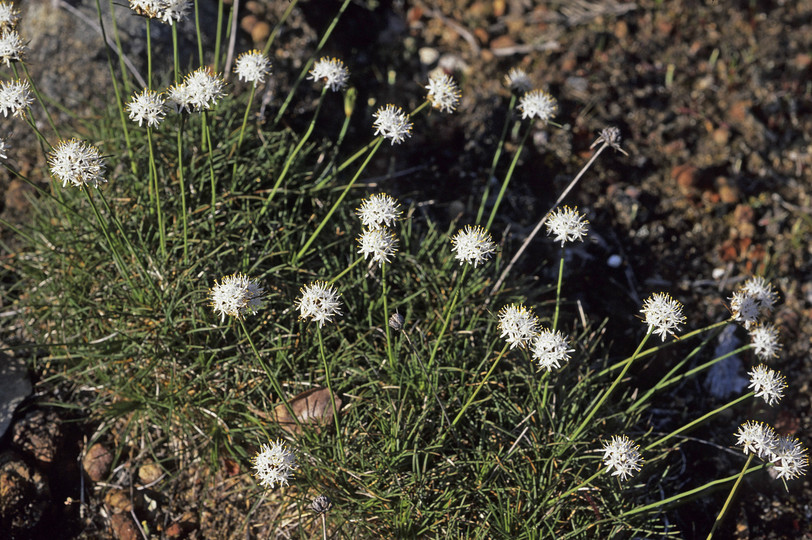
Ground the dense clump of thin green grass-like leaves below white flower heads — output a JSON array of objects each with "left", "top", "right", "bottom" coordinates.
[{"left": 0, "top": 2, "right": 805, "bottom": 538}]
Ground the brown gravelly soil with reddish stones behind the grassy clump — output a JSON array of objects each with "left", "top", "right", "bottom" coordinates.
[{"left": 0, "top": 0, "right": 812, "bottom": 539}]
